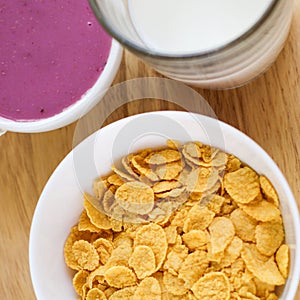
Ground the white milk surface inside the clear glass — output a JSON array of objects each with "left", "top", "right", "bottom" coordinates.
[{"left": 128, "top": 0, "right": 272, "bottom": 54}]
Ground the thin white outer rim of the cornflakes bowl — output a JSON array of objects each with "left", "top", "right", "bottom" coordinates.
[{"left": 29, "top": 111, "right": 300, "bottom": 300}]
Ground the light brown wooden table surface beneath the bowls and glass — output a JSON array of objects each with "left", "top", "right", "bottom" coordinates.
[{"left": 0, "top": 1, "right": 300, "bottom": 300}]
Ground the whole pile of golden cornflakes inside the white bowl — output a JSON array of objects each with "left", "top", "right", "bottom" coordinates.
[{"left": 64, "top": 140, "right": 290, "bottom": 300}]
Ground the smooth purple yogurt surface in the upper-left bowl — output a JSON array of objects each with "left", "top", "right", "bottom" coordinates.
[{"left": 0, "top": 0, "right": 112, "bottom": 121}]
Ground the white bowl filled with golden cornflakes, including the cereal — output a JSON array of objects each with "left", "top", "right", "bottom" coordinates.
[{"left": 29, "top": 111, "right": 300, "bottom": 300}]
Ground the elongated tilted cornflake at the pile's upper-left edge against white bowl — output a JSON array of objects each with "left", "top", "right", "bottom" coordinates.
[{"left": 83, "top": 193, "right": 111, "bottom": 230}]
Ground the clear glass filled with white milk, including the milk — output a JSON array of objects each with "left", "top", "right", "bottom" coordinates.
[{"left": 89, "top": 0, "right": 293, "bottom": 89}]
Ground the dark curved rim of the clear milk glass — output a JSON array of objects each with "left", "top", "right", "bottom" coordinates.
[{"left": 88, "top": 0, "right": 281, "bottom": 60}]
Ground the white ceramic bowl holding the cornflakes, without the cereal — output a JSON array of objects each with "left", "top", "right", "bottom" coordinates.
[{"left": 29, "top": 111, "right": 300, "bottom": 300}]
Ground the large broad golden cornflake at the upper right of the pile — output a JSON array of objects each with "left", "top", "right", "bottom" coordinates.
[{"left": 224, "top": 167, "right": 260, "bottom": 204}]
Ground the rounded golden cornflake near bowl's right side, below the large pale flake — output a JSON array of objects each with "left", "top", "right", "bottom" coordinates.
[{"left": 255, "top": 221, "right": 284, "bottom": 256}]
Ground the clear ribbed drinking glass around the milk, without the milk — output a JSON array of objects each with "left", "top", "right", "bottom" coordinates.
[{"left": 89, "top": 0, "right": 293, "bottom": 89}]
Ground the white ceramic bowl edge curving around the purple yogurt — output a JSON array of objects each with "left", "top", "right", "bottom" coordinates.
[{"left": 0, "top": 39, "right": 123, "bottom": 135}]
